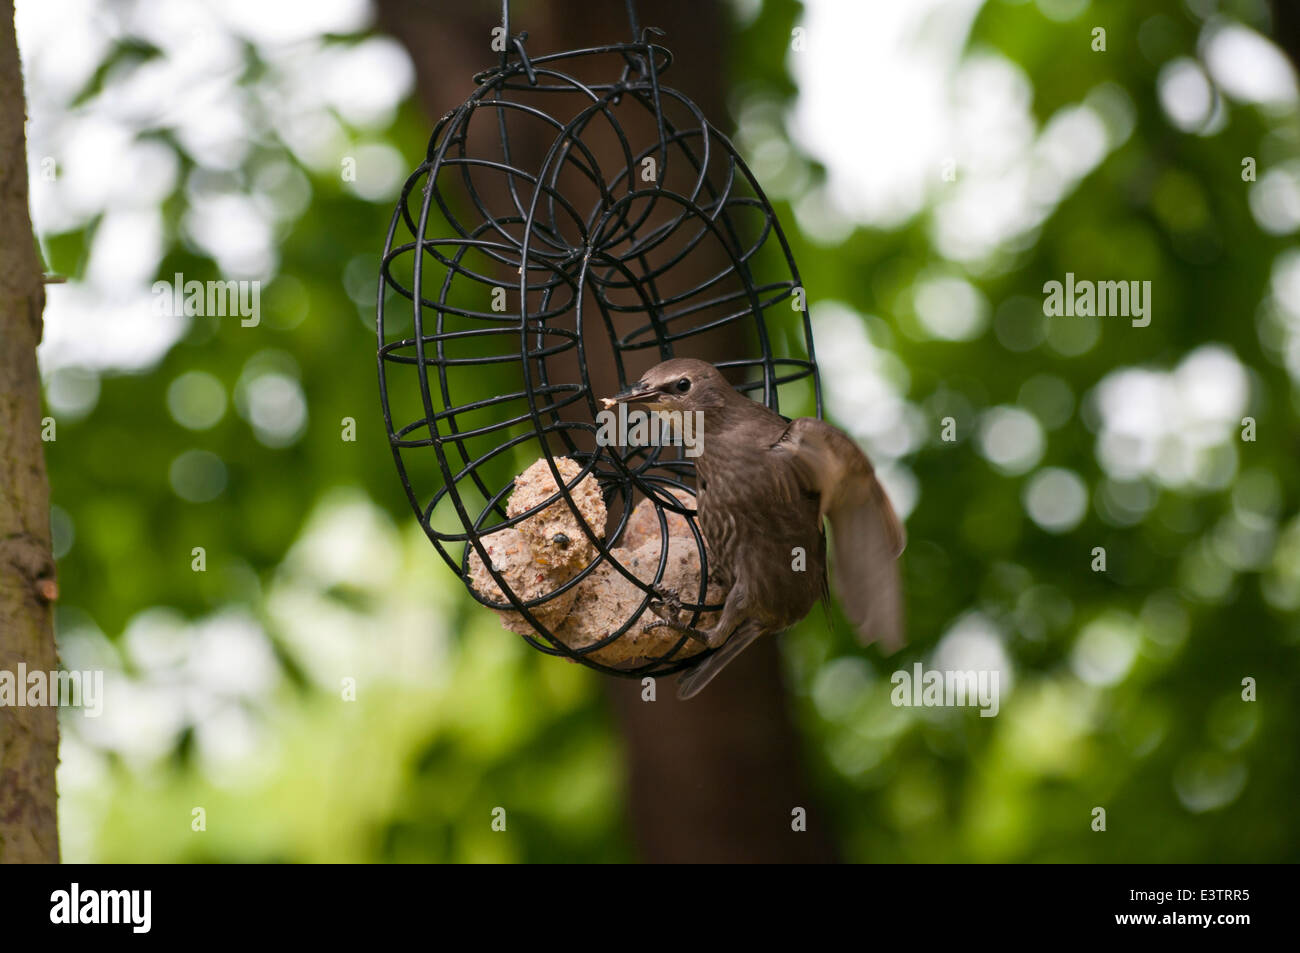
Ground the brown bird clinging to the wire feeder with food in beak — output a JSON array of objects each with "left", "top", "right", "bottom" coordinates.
[{"left": 603, "top": 358, "right": 906, "bottom": 698}]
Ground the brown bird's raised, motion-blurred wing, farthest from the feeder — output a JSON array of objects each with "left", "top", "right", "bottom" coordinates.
[{"left": 772, "top": 417, "right": 906, "bottom": 651}]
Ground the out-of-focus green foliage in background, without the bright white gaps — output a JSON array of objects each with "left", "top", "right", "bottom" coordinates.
[{"left": 27, "top": 0, "right": 1300, "bottom": 862}]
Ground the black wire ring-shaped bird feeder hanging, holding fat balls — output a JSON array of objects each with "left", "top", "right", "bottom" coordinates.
[{"left": 377, "top": 0, "right": 822, "bottom": 677}]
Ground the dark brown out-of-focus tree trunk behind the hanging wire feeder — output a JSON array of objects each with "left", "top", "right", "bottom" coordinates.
[{"left": 378, "top": 0, "right": 836, "bottom": 862}]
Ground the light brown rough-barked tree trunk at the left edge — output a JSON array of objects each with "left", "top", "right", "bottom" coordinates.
[{"left": 0, "top": 0, "right": 59, "bottom": 863}]
